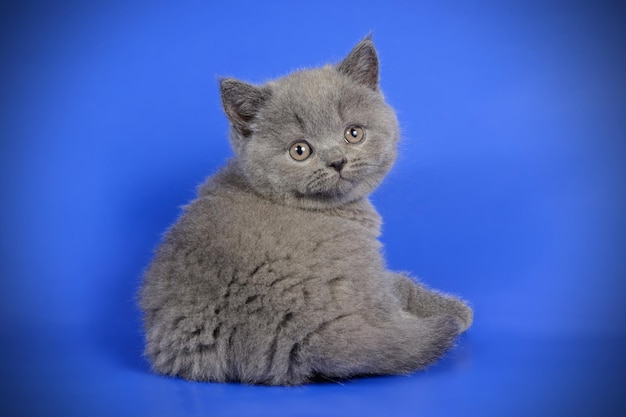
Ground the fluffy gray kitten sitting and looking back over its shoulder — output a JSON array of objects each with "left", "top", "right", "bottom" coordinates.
[{"left": 140, "top": 38, "right": 472, "bottom": 385}]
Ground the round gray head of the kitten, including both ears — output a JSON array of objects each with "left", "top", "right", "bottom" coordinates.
[{"left": 220, "top": 37, "right": 399, "bottom": 208}]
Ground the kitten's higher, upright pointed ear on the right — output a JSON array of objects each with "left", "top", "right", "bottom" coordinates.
[{"left": 337, "top": 36, "right": 378, "bottom": 90}]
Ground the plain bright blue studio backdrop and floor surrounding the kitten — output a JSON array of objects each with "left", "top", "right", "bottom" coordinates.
[{"left": 0, "top": 0, "right": 626, "bottom": 416}]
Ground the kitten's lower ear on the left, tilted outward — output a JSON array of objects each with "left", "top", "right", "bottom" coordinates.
[{"left": 219, "top": 78, "right": 270, "bottom": 137}]
